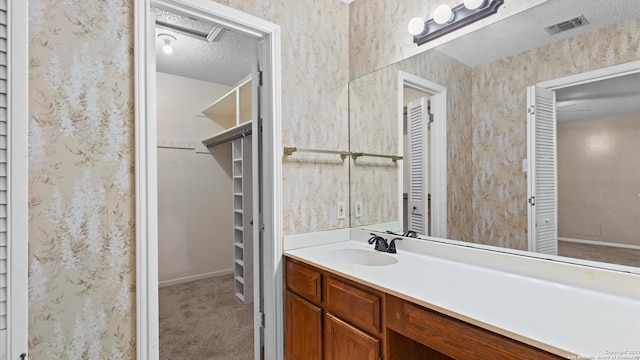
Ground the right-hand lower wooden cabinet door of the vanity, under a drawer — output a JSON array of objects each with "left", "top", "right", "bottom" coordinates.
[{"left": 324, "top": 314, "right": 380, "bottom": 360}]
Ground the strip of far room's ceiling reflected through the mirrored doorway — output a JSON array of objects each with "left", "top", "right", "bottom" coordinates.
[{"left": 556, "top": 73, "right": 640, "bottom": 121}]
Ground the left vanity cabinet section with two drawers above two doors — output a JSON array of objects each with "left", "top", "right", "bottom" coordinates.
[{"left": 285, "top": 259, "right": 384, "bottom": 360}]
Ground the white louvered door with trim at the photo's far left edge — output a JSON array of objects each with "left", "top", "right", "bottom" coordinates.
[{"left": 0, "top": 0, "right": 28, "bottom": 360}]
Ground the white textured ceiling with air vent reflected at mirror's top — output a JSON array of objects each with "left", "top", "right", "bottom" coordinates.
[{"left": 437, "top": 0, "right": 640, "bottom": 66}]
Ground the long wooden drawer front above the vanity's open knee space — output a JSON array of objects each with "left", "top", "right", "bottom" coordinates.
[{"left": 386, "top": 295, "right": 564, "bottom": 360}]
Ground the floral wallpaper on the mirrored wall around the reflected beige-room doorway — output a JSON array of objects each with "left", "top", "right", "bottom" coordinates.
[{"left": 472, "top": 18, "right": 640, "bottom": 250}]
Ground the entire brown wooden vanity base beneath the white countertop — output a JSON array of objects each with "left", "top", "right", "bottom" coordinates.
[{"left": 285, "top": 258, "right": 565, "bottom": 360}]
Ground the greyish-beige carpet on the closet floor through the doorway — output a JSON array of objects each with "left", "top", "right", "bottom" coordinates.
[{"left": 159, "top": 274, "right": 253, "bottom": 360}]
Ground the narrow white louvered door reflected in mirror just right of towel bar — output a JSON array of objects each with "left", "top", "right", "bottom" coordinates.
[{"left": 407, "top": 97, "right": 429, "bottom": 234}]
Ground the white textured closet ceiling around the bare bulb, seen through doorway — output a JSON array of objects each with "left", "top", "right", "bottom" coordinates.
[{"left": 154, "top": 9, "right": 259, "bottom": 85}]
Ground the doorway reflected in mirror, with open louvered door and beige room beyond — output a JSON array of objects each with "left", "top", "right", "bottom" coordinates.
[{"left": 527, "top": 62, "right": 640, "bottom": 266}]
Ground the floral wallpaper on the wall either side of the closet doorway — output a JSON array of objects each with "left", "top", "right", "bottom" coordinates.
[{"left": 29, "top": 0, "right": 349, "bottom": 359}]
